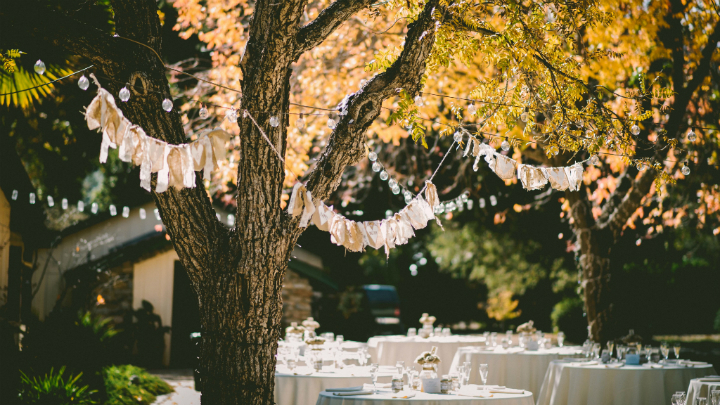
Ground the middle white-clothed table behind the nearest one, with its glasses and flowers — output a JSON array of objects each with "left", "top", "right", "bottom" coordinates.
[{"left": 450, "top": 321, "right": 583, "bottom": 393}]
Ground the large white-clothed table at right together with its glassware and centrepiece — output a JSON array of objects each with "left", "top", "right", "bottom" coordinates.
[{"left": 537, "top": 331, "right": 720, "bottom": 405}]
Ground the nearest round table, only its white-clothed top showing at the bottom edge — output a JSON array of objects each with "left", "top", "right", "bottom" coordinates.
[{"left": 316, "top": 389, "right": 534, "bottom": 405}]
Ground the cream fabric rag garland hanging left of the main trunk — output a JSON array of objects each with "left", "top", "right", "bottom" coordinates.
[{"left": 85, "top": 74, "right": 231, "bottom": 193}]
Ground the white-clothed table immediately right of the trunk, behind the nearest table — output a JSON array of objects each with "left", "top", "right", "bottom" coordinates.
[{"left": 275, "top": 366, "right": 393, "bottom": 405}]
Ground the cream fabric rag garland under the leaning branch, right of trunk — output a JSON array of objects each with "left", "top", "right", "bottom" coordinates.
[{"left": 287, "top": 181, "right": 439, "bottom": 255}]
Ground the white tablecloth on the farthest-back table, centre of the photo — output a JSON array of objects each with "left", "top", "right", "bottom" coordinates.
[{"left": 368, "top": 336, "right": 485, "bottom": 376}]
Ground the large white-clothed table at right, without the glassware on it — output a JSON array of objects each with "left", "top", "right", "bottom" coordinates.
[{"left": 537, "top": 360, "right": 715, "bottom": 405}]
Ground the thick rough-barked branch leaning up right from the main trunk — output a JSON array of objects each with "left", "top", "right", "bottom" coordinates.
[{"left": 308, "top": 0, "right": 439, "bottom": 200}]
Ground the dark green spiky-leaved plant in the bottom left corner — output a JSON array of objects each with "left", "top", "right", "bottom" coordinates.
[{"left": 18, "top": 367, "right": 97, "bottom": 405}]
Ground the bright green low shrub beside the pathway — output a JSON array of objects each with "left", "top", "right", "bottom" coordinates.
[{"left": 103, "top": 365, "right": 173, "bottom": 405}]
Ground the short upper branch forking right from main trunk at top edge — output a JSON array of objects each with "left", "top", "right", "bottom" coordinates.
[{"left": 295, "top": 0, "right": 373, "bottom": 58}]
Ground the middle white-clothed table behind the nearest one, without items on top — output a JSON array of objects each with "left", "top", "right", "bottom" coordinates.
[{"left": 450, "top": 347, "right": 582, "bottom": 395}]
